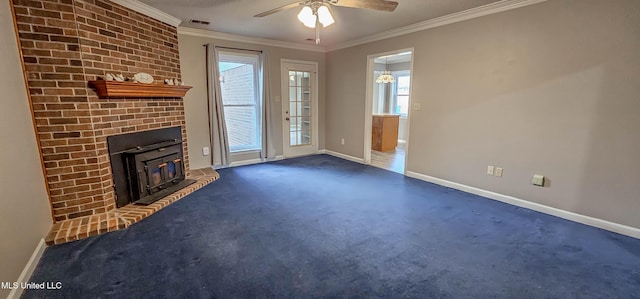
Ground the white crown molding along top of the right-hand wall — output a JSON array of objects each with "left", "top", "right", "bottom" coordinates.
[{"left": 327, "top": 0, "right": 548, "bottom": 51}]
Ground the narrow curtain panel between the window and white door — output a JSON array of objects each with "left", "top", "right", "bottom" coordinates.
[{"left": 259, "top": 52, "right": 276, "bottom": 159}]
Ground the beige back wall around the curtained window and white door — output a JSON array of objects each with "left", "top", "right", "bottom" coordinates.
[{"left": 178, "top": 34, "right": 326, "bottom": 169}]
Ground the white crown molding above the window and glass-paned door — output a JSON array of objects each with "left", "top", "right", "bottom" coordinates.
[{"left": 178, "top": 26, "right": 327, "bottom": 53}]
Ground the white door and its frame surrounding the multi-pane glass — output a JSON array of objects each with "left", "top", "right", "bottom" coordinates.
[{"left": 280, "top": 58, "right": 318, "bottom": 158}]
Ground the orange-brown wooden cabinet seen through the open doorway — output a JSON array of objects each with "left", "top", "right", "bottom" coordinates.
[{"left": 371, "top": 114, "right": 400, "bottom": 152}]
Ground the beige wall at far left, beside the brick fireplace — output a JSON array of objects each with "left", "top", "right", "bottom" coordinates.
[{"left": 0, "top": 1, "right": 52, "bottom": 298}]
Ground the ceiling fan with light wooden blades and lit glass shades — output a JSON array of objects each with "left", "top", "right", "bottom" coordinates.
[{"left": 254, "top": 0, "right": 398, "bottom": 45}]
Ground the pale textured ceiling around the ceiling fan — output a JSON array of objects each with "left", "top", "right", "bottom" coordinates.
[{"left": 141, "top": 0, "right": 498, "bottom": 47}]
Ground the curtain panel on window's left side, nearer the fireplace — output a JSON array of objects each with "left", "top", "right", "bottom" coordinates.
[{"left": 206, "top": 44, "right": 230, "bottom": 167}]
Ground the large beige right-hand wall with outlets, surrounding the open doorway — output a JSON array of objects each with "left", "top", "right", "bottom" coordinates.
[{"left": 325, "top": 0, "right": 640, "bottom": 228}]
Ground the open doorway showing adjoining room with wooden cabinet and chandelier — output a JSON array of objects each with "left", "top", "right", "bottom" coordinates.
[{"left": 365, "top": 49, "right": 413, "bottom": 174}]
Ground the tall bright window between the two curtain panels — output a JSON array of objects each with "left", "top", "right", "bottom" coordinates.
[{"left": 219, "top": 52, "right": 262, "bottom": 152}]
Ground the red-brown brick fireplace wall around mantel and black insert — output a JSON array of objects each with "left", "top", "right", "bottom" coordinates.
[{"left": 13, "top": 0, "right": 189, "bottom": 221}]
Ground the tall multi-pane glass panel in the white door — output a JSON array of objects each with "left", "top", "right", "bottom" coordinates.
[{"left": 289, "top": 71, "right": 313, "bottom": 146}]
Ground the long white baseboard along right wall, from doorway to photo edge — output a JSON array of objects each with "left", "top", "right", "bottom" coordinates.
[{"left": 406, "top": 171, "right": 640, "bottom": 239}]
